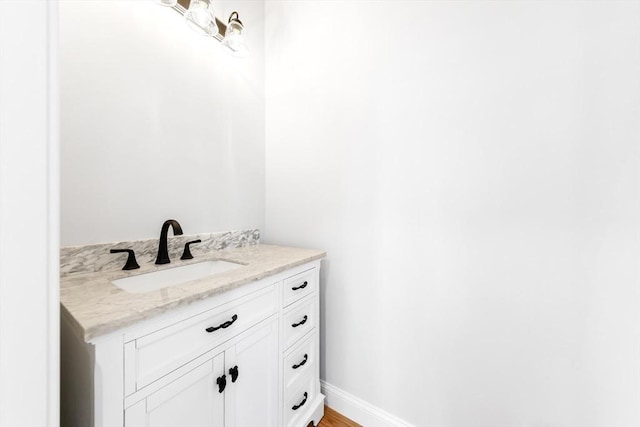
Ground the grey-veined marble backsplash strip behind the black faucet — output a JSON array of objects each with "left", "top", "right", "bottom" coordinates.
[{"left": 60, "top": 229, "right": 260, "bottom": 276}]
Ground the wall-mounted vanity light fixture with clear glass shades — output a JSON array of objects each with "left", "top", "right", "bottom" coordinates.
[{"left": 156, "top": 0, "right": 248, "bottom": 57}]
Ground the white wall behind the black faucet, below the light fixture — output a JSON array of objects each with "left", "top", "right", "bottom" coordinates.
[{"left": 60, "top": 0, "right": 264, "bottom": 246}]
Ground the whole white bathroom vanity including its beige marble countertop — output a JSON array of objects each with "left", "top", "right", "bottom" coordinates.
[{"left": 61, "top": 244, "right": 324, "bottom": 427}]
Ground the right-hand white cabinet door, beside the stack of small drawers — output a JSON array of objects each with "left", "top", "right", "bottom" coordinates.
[{"left": 225, "top": 319, "right": 279, "bottom": 427}]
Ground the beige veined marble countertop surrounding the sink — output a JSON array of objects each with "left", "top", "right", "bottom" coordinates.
[{"left": 60, "top": 244, "right": 325, "bottom": 342}]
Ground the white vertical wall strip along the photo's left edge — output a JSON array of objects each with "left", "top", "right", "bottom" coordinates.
[{"left": 0, "top": 0, "right": 60, "bottom": 427}]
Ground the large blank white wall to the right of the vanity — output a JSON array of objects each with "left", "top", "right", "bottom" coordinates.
[{"left": 263, "top": 0, "right": 640, "bottom": 427}]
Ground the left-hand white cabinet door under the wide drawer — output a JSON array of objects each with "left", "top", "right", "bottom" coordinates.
[{"left": 125, "top": 353, "right": 225, "bottom": 427}]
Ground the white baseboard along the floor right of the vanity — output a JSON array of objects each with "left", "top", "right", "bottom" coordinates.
[{"left": 320, "top": 380, "right": 414, "bottom": 427}]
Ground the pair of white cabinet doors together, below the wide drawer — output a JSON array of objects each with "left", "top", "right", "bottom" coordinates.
[{"left": 124, "top": 319, "right": 278, "bottom": 427}]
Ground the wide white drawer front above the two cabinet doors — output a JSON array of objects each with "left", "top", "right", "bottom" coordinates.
[{"left": 125, "top": 285, "right": 277, "bottom": 394}]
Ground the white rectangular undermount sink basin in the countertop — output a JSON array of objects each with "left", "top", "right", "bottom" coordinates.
[{"left": 111, "top": 260, "right": 243, "bottom": 294}]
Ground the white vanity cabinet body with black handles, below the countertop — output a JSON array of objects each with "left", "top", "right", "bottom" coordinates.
[{"left": 61, "top": 261, "right": 324, "bottom": 427}]
